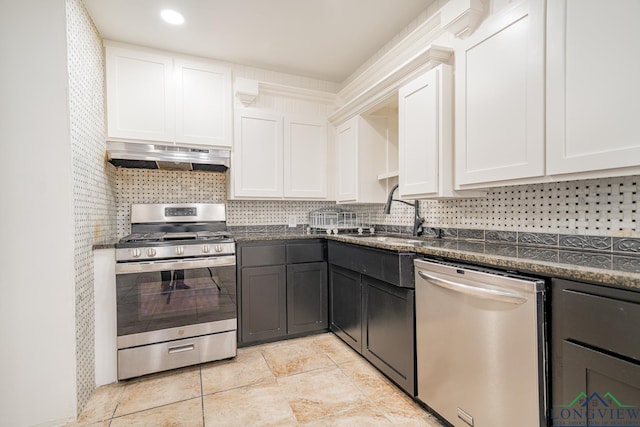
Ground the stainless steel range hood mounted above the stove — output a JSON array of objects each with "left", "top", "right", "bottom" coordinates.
[{"left": 107, "top": 141, "right": 231, "bottom": 172}]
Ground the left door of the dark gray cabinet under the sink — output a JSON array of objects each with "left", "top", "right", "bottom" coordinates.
[{"left": 329, "top": 266, "right": 362, "bottom": 353}]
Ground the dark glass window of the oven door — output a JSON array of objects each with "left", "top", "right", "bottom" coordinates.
[{"left": 116, "top": 266, "right": 236, "bottom": 336}]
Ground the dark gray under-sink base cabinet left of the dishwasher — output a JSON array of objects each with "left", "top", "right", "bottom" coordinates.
[{"left": 328, "top": 241, "right": 415, "bottom": 396}]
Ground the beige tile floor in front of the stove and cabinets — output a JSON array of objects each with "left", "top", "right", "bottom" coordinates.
[{"left": 69, "top": 334, "right": 441, "bottom": 427}]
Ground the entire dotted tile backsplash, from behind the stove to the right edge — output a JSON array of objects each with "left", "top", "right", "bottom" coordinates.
[{"left": 117, "top": 169, "right": 640, "bottom": 237}]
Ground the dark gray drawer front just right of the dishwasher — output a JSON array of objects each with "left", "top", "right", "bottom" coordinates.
[{"left": 562, "top": 289, "right": 640, "bottom": 361}]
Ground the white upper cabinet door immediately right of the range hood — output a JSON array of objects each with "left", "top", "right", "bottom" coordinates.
[{"left": 232, "top": 109, "right": 283, "bottom": 197}]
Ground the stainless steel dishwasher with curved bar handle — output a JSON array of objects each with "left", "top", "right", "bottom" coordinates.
[{"left": 414, "top": 259, "right": 547, "bottom": 427}]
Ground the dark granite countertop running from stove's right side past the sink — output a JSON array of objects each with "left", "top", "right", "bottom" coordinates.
[{"left": 235, "top": 232, "right": 640, "bottom": 292}]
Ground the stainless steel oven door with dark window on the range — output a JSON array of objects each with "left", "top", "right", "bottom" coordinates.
[{"left": 116, "top": 255, "right": 237, "bottom": 349}]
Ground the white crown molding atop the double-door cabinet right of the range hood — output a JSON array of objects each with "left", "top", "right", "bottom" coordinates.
[{"left": 234, "top": 77, "right": 337, "bottom": 107}]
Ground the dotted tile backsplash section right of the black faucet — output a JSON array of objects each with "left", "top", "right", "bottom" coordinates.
[{"left": 422, "top": 176, "right": 640, "bottom": 237}]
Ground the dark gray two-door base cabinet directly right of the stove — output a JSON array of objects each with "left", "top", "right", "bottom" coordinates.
[{"left": 237, "top": 239, "right": 328, "bottom": 345}]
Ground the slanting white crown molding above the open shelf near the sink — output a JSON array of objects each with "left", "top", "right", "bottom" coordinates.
[{"left": 329, "top": 45, "right": 454, "bottom": 125}]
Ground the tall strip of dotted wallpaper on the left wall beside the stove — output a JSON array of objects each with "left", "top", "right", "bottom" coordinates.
[{"left": 66, "top": 0, "right": 116, "bottom": 413}]
